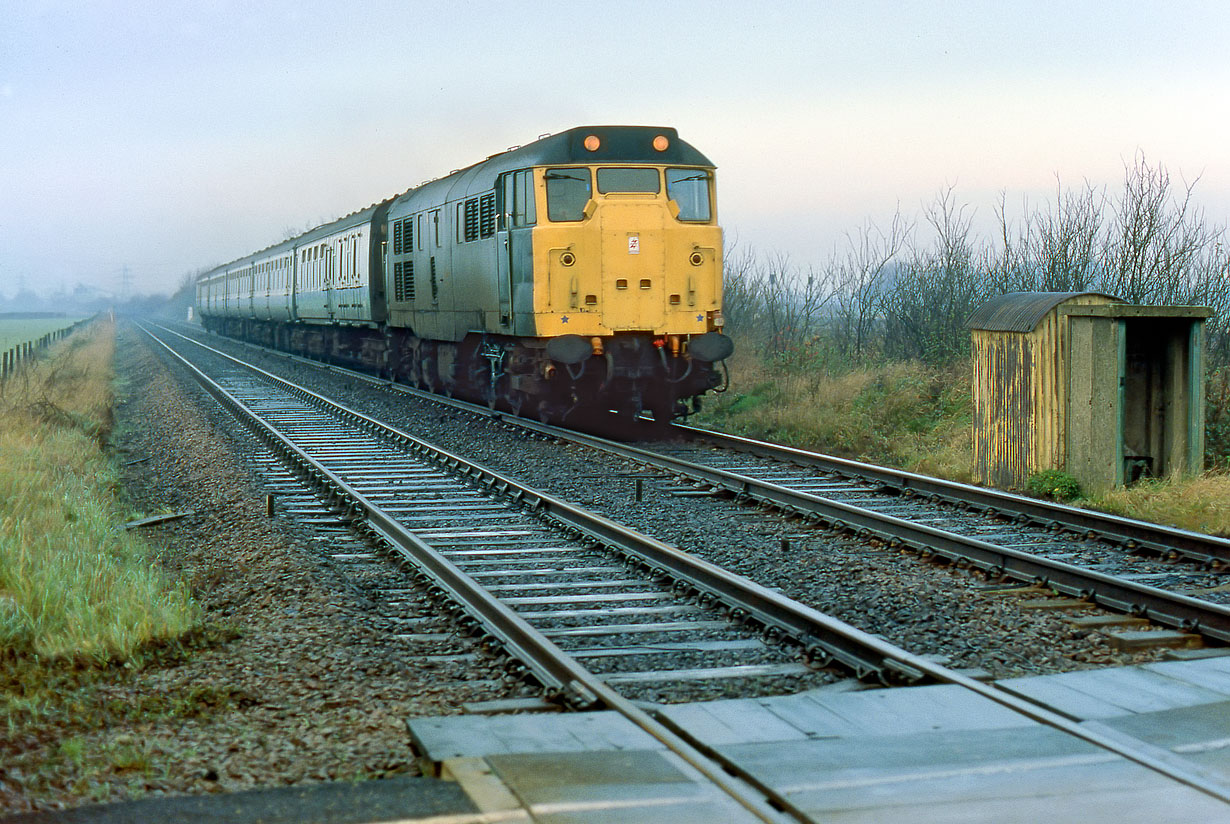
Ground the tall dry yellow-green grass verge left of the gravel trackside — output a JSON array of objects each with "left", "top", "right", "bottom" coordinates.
[{"left": 0, "top": 322, "right": 196, "bottom": 660}]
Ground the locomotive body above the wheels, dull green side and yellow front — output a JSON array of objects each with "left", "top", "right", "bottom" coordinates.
[{"left": 385, "top": 127, "right": 722, "bottom": 341}]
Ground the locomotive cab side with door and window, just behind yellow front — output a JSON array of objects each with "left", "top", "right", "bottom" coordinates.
[{"left": 496, "top": 168, "right": 536, "bottom": 333}]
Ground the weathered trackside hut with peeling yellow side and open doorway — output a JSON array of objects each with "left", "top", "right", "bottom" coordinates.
[{"left": 967, "top": 291, "right": 1212, "bottom": 491}]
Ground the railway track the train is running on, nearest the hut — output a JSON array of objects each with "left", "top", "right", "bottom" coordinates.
[{"left": 168, "top": 319, "right": 1230, "bottom": 643}]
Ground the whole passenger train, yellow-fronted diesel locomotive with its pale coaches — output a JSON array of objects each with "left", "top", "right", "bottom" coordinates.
[{"left": 196, "top": 125, "right": 734, "bottom": 423}]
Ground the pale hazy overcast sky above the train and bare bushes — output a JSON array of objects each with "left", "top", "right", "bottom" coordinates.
[{"left": 0, "top": 0, "right": 1230, "bottom": 294}]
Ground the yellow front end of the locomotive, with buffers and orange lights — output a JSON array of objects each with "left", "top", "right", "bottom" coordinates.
[{"left": 506, "top": 128, "right": 732, "bottom": 421}]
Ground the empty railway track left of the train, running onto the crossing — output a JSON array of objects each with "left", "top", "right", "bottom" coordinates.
[{"left": 139, "top": 322, "right": 1230, "bottom": 820}]
